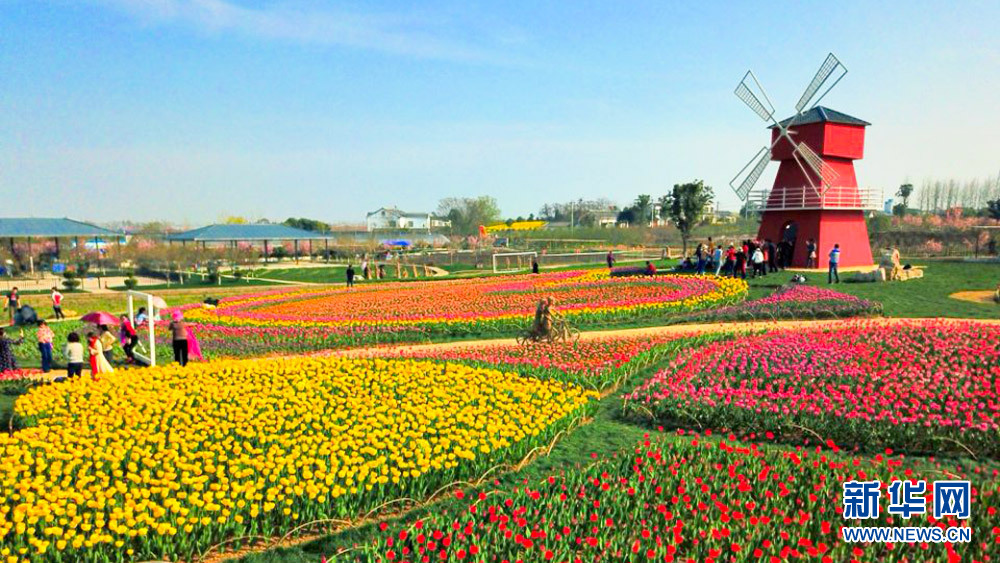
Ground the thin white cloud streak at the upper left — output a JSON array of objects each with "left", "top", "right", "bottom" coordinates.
[{"left": 94, "top": 0, "right": 508, "bottom": 63}]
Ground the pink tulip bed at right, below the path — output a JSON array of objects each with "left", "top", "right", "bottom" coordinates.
[{"left": 628, "top": 321, "right": 1000, "bottom": 456}]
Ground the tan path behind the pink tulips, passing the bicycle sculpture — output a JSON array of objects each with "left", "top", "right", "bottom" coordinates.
[{"left": 331, "top": 317, "right": 1000, "bottom": 357}]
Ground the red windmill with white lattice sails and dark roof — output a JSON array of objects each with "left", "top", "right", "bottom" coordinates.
[{"left": 729, "top": 53, "right": 881, "bottom": 268}]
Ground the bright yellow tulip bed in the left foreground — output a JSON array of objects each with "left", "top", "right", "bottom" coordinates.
[{"left": 0, "top": 357, "right": 595, "bottom": 561}]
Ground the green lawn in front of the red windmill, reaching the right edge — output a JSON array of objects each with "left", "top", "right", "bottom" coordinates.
[{"left": 748, "top": 261, "right": 1000, "bottom": 319}]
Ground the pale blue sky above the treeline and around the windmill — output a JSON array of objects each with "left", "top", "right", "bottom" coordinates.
[{"left": 0, "top": 0, "right": 1000, "bottom": 224}]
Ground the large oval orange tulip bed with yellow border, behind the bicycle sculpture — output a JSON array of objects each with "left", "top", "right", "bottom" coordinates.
[{"left": 188, "top": 270, "right": 747, "bottom": 335}]
